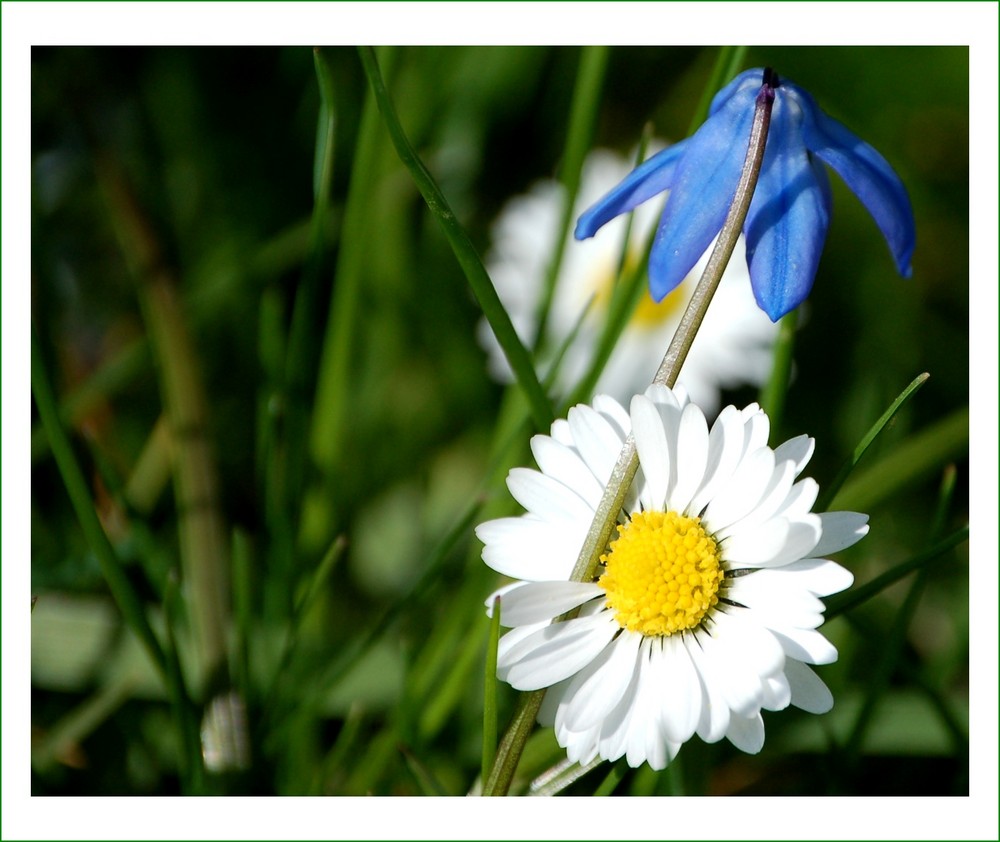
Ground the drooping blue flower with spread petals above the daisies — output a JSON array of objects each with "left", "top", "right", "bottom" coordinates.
[{"left": 576, "top": 69, "right": 915, "bottom": 321}]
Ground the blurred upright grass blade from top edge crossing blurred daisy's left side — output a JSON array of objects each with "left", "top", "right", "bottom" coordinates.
[{"left": 532, "top": 47, "right": 608, "bottom": 349}]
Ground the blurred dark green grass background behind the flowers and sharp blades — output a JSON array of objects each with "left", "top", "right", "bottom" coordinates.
[{"left": 31, "top": 47, "right": 969, "bottom": 795}]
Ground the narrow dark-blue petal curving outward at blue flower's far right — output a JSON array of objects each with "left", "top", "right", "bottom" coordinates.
[{"left": 789, "top": 85, "right": 916, "bottom": 278}]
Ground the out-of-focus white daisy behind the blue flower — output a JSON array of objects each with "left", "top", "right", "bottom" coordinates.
[{"left": 478, "top": 150, "right": 776, "bottom": 413}]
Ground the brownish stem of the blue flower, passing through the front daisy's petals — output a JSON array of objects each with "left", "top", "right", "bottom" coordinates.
[{"left": 483, "top": 68, "right": 777, "bottom": 795}]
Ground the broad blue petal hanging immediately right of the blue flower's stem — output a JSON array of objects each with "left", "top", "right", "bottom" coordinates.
[{"left": 743, "top": 97, "right": 831, "bottom": 322}]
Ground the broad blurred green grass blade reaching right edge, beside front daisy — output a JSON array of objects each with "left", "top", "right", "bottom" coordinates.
[{"left": 820, "top": 407, "right": 969, "bottom": 512}]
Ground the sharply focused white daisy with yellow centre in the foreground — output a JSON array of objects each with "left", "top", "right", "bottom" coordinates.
[{"left": 476, "top": 385, "right": 868, "bottom": 769}]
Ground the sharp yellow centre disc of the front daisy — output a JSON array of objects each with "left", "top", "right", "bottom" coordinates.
[{"left": 598, "top": 511, "right": 723, "bottom": 635}]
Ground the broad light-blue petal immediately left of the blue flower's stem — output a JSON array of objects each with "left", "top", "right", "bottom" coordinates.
[{"left": 649, "top": 87, "right": 757, "bottom": 301}]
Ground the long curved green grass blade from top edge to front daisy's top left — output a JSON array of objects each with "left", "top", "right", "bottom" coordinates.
[{"left": 358, "top": 47, "right": 555, "bottom": 430}]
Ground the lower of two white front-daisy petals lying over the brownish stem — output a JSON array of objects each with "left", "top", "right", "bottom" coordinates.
[{"left": 497, "top": 612, "right": 618, "bottom": 690}]
